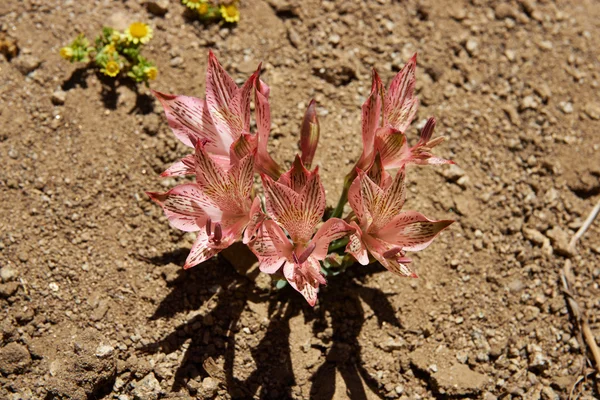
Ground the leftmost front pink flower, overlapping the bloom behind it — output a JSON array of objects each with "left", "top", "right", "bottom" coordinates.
[{"left": 147, "top": 142, "right": 262, "bottom": 268}]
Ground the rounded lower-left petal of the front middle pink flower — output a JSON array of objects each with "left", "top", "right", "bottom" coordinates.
[{"left": 250, "top": 220, "right": 292, "bottom": 274}]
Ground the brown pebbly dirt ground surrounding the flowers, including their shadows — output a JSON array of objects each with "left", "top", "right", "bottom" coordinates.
[{"left": 0, "top": 0, "right": 600, "bottom": 400}]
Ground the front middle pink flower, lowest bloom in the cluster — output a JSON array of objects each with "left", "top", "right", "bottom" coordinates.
[{"left": 251, "top": 156, "right": 354, "bottom": 306}]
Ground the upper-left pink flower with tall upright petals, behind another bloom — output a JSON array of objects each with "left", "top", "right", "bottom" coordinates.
[{"left": 153, "top": 51, "right": 280, "bottom": 177}]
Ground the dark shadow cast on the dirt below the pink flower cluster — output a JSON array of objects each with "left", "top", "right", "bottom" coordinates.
[{"left": 142, "top": 252, "right": 400, "bottom": 399}]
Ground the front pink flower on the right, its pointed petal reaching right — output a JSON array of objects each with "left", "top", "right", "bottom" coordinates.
[{"left": 346, "top": 160, "right": 454, "bottom": 278}]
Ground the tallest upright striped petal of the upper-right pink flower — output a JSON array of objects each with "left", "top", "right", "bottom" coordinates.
[{"left": 384, "top": 54, "right": 418, "bottom": 132}]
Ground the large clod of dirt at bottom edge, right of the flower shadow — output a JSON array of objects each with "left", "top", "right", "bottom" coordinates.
[{"left": 431, "top": 364, "right": 489, "bottom": 396}]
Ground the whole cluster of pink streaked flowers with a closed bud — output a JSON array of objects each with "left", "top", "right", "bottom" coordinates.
[{"left": 148, "top": 52, "right": 453, "bottom": 305}]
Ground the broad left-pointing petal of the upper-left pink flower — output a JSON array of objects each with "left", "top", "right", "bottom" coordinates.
[{"left": 152, "top": 90, "right": 233, "bottom": 158}]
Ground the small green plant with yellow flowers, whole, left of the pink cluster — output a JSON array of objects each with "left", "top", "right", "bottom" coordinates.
[{"left": 60, "top": 22, "right": 158, "bottom": 85}]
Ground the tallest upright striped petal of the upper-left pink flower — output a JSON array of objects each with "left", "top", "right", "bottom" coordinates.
[{"left": 206, "top": 51, "right": 245, "bottom": 141}]
